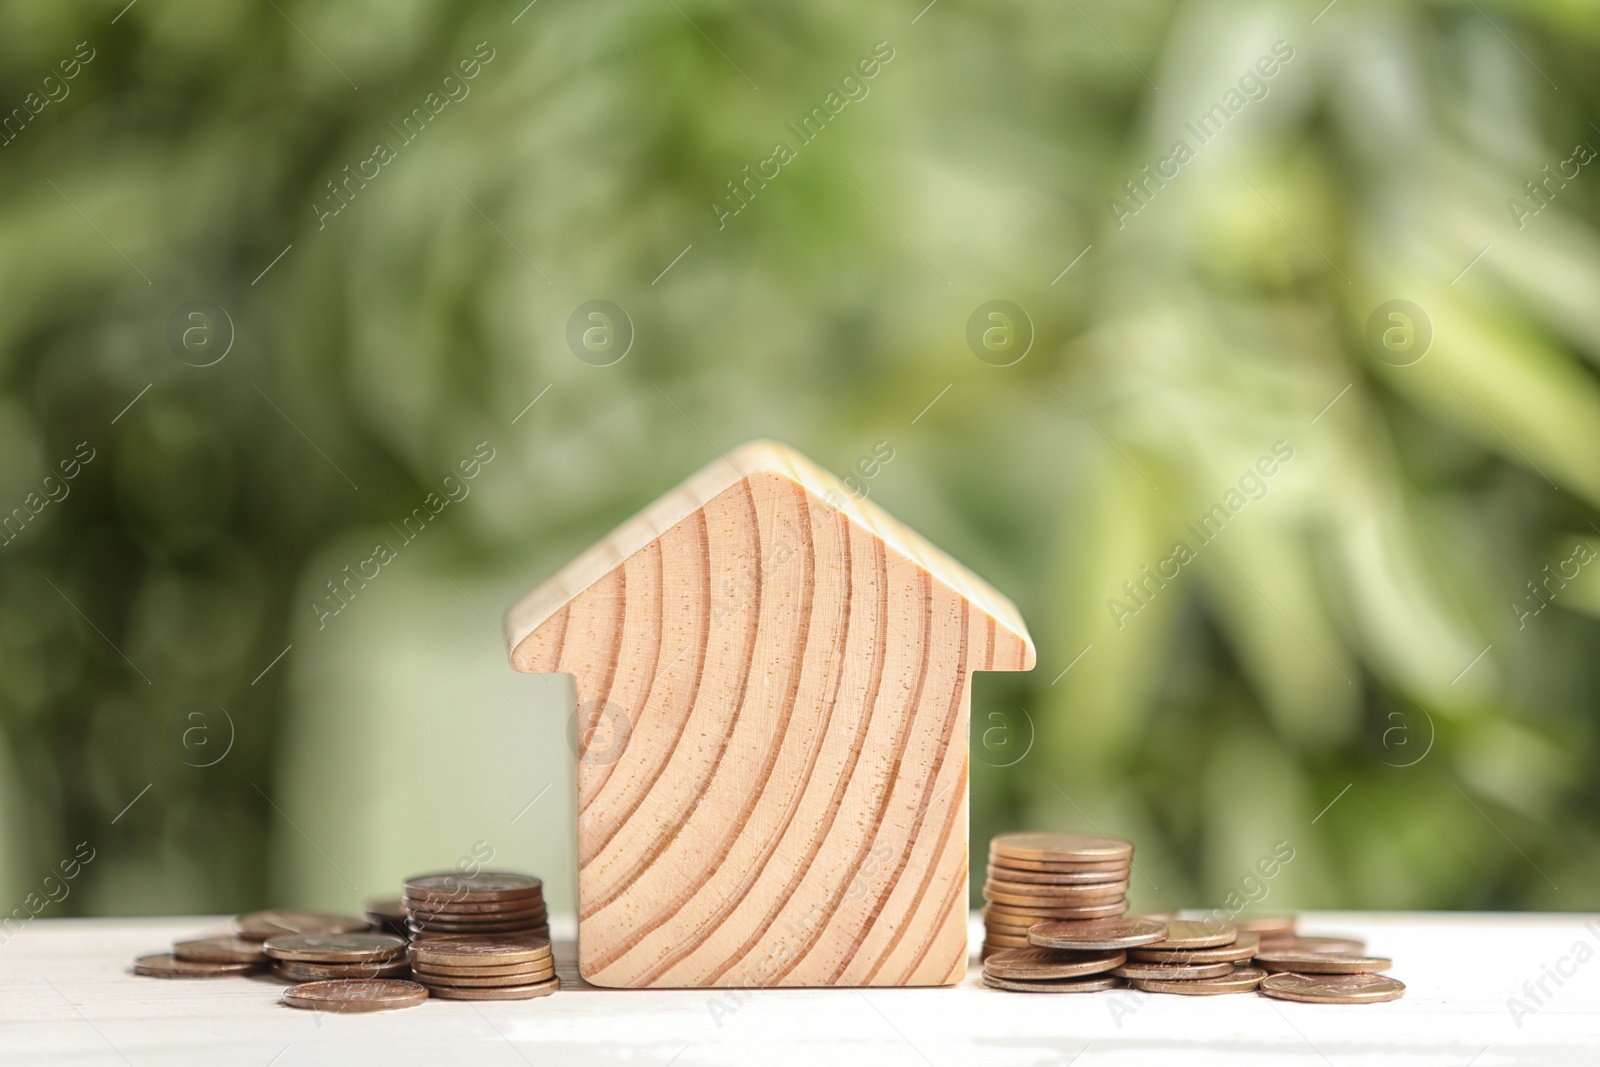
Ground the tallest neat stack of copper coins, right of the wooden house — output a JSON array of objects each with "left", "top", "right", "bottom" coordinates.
[{"left": 984, "top": 833, "right": 1133, "bottom": 958}]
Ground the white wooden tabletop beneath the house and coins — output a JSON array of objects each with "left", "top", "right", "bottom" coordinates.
[{"left": 0, "top": 913, "right": 1600, "bottom": 1067}]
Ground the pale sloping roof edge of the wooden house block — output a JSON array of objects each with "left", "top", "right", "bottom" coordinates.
[{"left": 506, "top": 442, "right": 1035, "bottom": 672}]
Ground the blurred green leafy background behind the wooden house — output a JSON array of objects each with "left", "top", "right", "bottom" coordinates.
[{"left": 0, "top": 0, "right": 1600, "bottom": 915}]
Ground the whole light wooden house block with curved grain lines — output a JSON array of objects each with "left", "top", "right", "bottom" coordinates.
[{"left": 506, "top": 442, "right": 1035, "bottom": 989}]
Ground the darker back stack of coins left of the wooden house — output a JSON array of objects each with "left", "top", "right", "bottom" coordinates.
[{"left": 402, "top": 870, "right": 550, "bottom": 941}]
